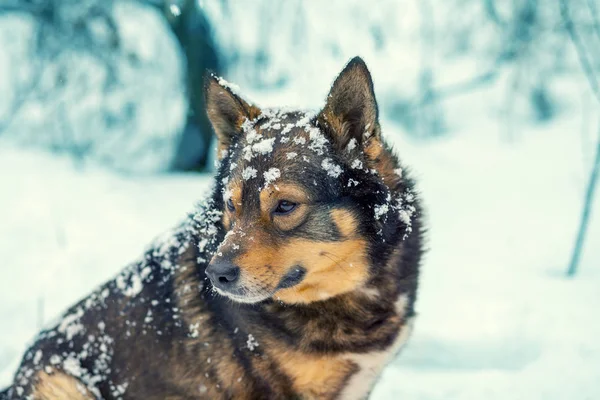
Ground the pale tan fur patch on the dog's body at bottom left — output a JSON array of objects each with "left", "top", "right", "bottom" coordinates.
[{"left": 33, "top": 371, "right": 95, "bottom": 400}]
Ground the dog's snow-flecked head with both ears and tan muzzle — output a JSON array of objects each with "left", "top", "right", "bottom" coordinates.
[{"left": 206, "top": 58, "right": 408, "bottom": 303}]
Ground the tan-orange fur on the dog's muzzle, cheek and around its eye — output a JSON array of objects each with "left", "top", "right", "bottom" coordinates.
[{"left": 215, "top": 183, "right": 368, "bottom": 303}]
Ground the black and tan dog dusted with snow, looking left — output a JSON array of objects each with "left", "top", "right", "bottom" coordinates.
[{"left": 2, "top": 57, "right": 423, "bottom": 400}]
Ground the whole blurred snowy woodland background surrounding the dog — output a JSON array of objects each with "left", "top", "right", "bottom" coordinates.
[{"left": 0, "top": 0, "right": 600, "bottom": 400}]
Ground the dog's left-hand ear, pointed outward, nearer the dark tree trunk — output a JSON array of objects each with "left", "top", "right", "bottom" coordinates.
[{"left": 204, "top": 72, "right": 261, "bottom": 159}]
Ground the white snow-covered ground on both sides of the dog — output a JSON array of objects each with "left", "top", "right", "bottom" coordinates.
[{"left": 0, "top": 79, "right": 600, "bottom": 400}]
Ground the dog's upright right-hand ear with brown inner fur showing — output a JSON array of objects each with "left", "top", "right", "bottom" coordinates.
[{"left": 317, "top": 57, "right": 379, "bottom": 150}]
